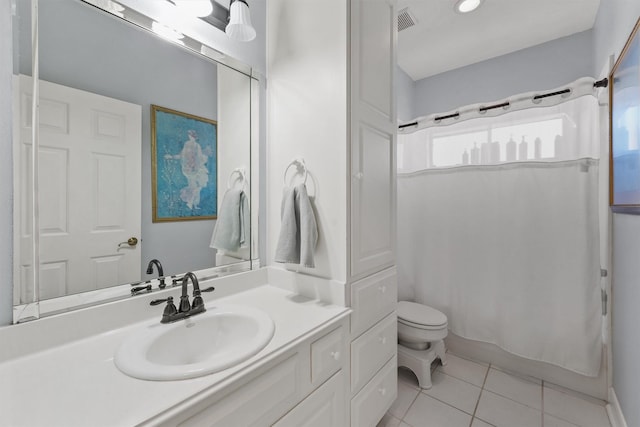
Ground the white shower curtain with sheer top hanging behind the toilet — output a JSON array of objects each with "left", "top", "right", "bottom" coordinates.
[{"left": 398, "top": 92, "right": 602, "bottom": 376}]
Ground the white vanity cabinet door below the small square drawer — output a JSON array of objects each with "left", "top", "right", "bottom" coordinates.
[{"left": 273, "top": 371, "right": 347, "bottom": 427}]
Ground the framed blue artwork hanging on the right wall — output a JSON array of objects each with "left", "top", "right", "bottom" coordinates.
[{"left": 609, "top": 19, "right": 640, "bottom": 214}]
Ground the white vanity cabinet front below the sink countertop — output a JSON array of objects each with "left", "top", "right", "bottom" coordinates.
[{"left": 149, "top": 318, "right": 349, "bottom": 427}]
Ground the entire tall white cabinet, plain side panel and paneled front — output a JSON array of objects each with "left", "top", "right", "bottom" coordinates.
[{"left": 267, "top": 0, "right": 397, "bottom": 427}]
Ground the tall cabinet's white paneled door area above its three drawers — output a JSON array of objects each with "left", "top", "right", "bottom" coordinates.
[{"left": 350, "top": 0, "right": 397, "bottom": 279}]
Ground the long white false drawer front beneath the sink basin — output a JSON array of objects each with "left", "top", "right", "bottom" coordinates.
[{"left": 178, "top": 353, "right": 301, "bottom": 427}]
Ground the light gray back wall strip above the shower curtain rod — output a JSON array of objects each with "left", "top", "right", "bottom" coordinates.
[{"left": 413, "top": 30, "right": 593, "bottom": 117}]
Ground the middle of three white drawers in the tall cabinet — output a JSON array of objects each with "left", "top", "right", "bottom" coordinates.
[{"left": 351, "top": 311, "right": 398, "bottom": 394}]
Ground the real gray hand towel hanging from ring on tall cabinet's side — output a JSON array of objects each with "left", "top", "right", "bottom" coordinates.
[{"left": 275, "top": 184, "right": 318, "bottom": 267}]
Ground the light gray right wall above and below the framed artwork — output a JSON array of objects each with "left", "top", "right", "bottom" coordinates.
[{"left": 593, "top": 0, "right": 640, "bottom": 427}]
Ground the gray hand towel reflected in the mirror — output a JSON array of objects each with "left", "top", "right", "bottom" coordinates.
[{"left": 209, "top": 189, "right": 249, "bottom": 252}]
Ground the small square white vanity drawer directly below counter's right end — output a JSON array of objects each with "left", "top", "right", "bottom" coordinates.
[{"left": 311, "top": 326, "right": 346, "bottom": 385}]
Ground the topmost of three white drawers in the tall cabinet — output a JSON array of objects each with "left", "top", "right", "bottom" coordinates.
[{"left": 351, "top": 268, "right": 398, "bottom": 337}]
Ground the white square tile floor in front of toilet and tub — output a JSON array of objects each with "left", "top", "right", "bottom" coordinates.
[{"left": 377, "top": 353, "right": 611, "bottom": 427}]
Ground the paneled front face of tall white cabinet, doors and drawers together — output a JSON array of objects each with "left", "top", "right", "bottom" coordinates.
[{"left": 349, "top": 0, "right": 397, "bottom": 427}]
